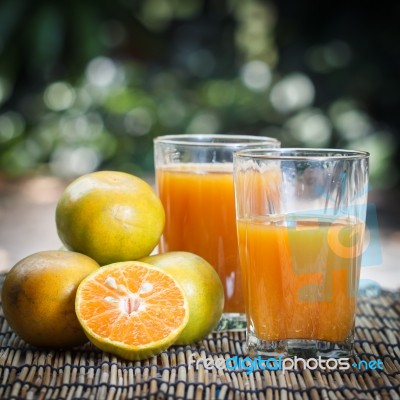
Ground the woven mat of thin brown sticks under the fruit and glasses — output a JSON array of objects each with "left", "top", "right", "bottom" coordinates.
[{"left": 0, "top": 284, "right": 400, "bottom": 400}]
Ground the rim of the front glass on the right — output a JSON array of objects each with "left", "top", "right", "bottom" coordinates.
[{"left": 233, "top": 147, "right": 370, "bottom": 161}]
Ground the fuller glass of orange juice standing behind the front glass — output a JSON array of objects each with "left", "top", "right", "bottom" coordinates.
[{"left": 154, "top": 134, "right": 280, "bottom": 330}]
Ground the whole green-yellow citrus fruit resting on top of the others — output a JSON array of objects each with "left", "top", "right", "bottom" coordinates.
[{"left": 56, "top": 171, "right": 165, "bottom": 265}]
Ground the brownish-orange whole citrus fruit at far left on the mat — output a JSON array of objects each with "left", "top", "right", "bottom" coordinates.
[{"left": 1, "top": 251, "right": 99, "bottom": 347}]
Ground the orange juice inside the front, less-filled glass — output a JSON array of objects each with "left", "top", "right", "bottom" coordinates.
[{"left": 238, "top": 215, "right": 364, "bottom": 342}]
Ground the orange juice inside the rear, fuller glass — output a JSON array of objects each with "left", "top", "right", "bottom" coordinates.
[{"left": 157, "top": 163, "right": 244, "bottom": 313}]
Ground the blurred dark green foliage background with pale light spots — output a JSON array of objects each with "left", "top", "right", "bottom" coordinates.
[{"left": 0, "top": 0, "right": 400, "bottom": 189}]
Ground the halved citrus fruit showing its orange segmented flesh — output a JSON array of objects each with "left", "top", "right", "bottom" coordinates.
[{"left": 75, "top": 261, "right": 189, "bottom": 360}]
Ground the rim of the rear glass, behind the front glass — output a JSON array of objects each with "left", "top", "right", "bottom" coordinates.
[{"left": 153, "top": 133, "right": 281, "bottom": 147}]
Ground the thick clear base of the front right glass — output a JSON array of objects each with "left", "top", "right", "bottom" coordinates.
[{"left": 247, "top": 332, "right": 354, "bottom": 359}]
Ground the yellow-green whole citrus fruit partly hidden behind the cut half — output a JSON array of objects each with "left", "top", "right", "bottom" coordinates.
[{"left": 141, "top": 251, "right": 224, "bottom": 345}]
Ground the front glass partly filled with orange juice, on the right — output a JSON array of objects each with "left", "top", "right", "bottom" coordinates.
[{"left": 234, "top": 149, "right": 369, "bottom": 358}]
